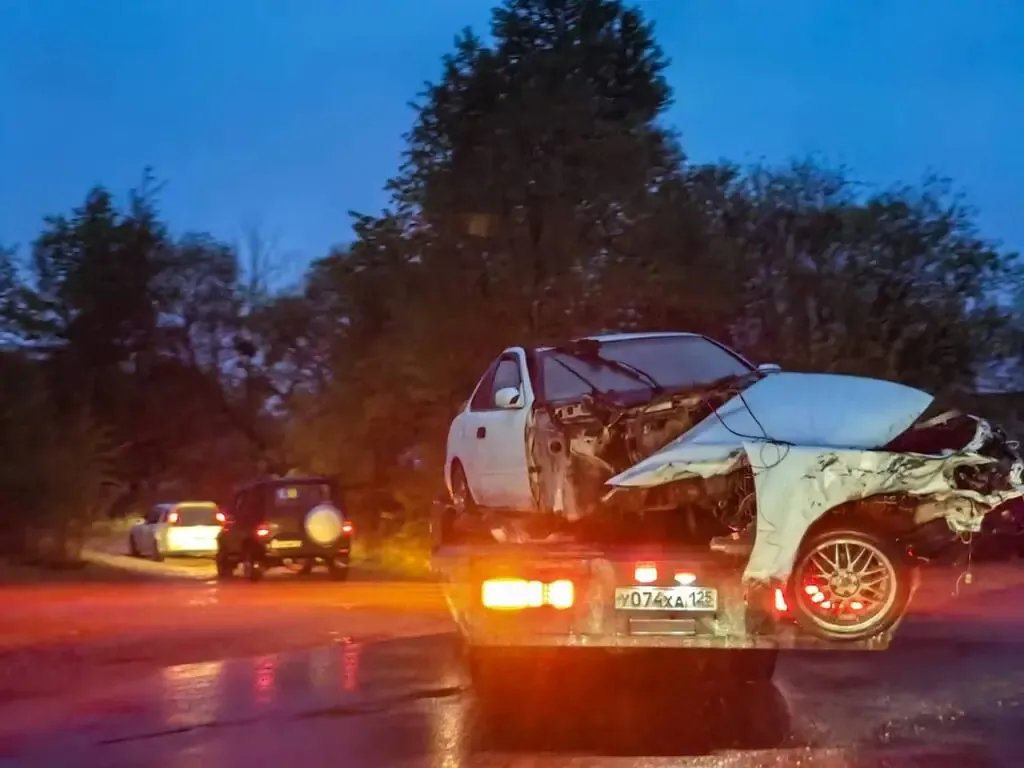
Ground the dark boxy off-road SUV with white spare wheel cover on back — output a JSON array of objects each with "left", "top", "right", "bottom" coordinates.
[{"left": 217, "top": 477, "right": 352, "bottom": 582}]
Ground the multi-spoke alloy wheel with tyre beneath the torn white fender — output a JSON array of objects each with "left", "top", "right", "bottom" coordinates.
[{"left": 790, "top": 524, "right": 913, "bottom": 642}]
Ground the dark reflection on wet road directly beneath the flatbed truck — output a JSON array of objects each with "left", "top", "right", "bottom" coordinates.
[{"left": 411, "top": 659, "right": 794, "bottom": 768}]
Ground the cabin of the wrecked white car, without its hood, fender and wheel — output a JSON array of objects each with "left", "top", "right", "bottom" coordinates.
[{"left": 444, "top": 333, "right": 778, "bottom": 519}]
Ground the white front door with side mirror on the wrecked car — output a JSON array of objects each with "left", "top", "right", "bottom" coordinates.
[{"left": 470, "top": 349, "right": 534, "bottom": 510}]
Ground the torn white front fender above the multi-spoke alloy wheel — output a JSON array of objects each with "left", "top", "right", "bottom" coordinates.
[{"left": 743, "top": 442, "right": 1024, "bottom": 582}]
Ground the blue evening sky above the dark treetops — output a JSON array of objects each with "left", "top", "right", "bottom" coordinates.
[{"left": 0, "top": 0, "right": 1024, "bottom": 286}]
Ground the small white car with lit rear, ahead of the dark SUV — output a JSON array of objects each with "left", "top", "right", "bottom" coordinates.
[{"left": 128, "top": 502, "right": 224, "bottom": 560}]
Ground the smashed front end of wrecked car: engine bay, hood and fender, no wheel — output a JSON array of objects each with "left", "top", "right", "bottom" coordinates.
[{"left": 516, "top": 372, "right": 1024, "bottom": 583}]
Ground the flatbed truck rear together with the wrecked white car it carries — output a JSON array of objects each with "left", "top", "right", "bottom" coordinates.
[{"left": 435, "top": 333, "right": 1024, "bottom": 664}]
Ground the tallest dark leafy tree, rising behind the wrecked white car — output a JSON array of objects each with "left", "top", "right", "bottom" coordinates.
[{"left": 284, "top": 0, "right": 679, "bottom": 495}]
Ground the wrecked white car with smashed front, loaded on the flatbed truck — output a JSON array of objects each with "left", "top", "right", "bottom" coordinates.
[{"left": 439, "top": 333, "right": 1024, "bottom": 640}]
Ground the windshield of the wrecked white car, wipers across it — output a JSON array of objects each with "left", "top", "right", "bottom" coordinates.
[{"left": 541, "top": 336, "right": 753, "bottom": 400}]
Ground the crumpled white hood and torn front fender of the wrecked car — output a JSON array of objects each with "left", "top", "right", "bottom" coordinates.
[{"left": 607, "top": 373, "right": 1024, "bottom": 582}]
